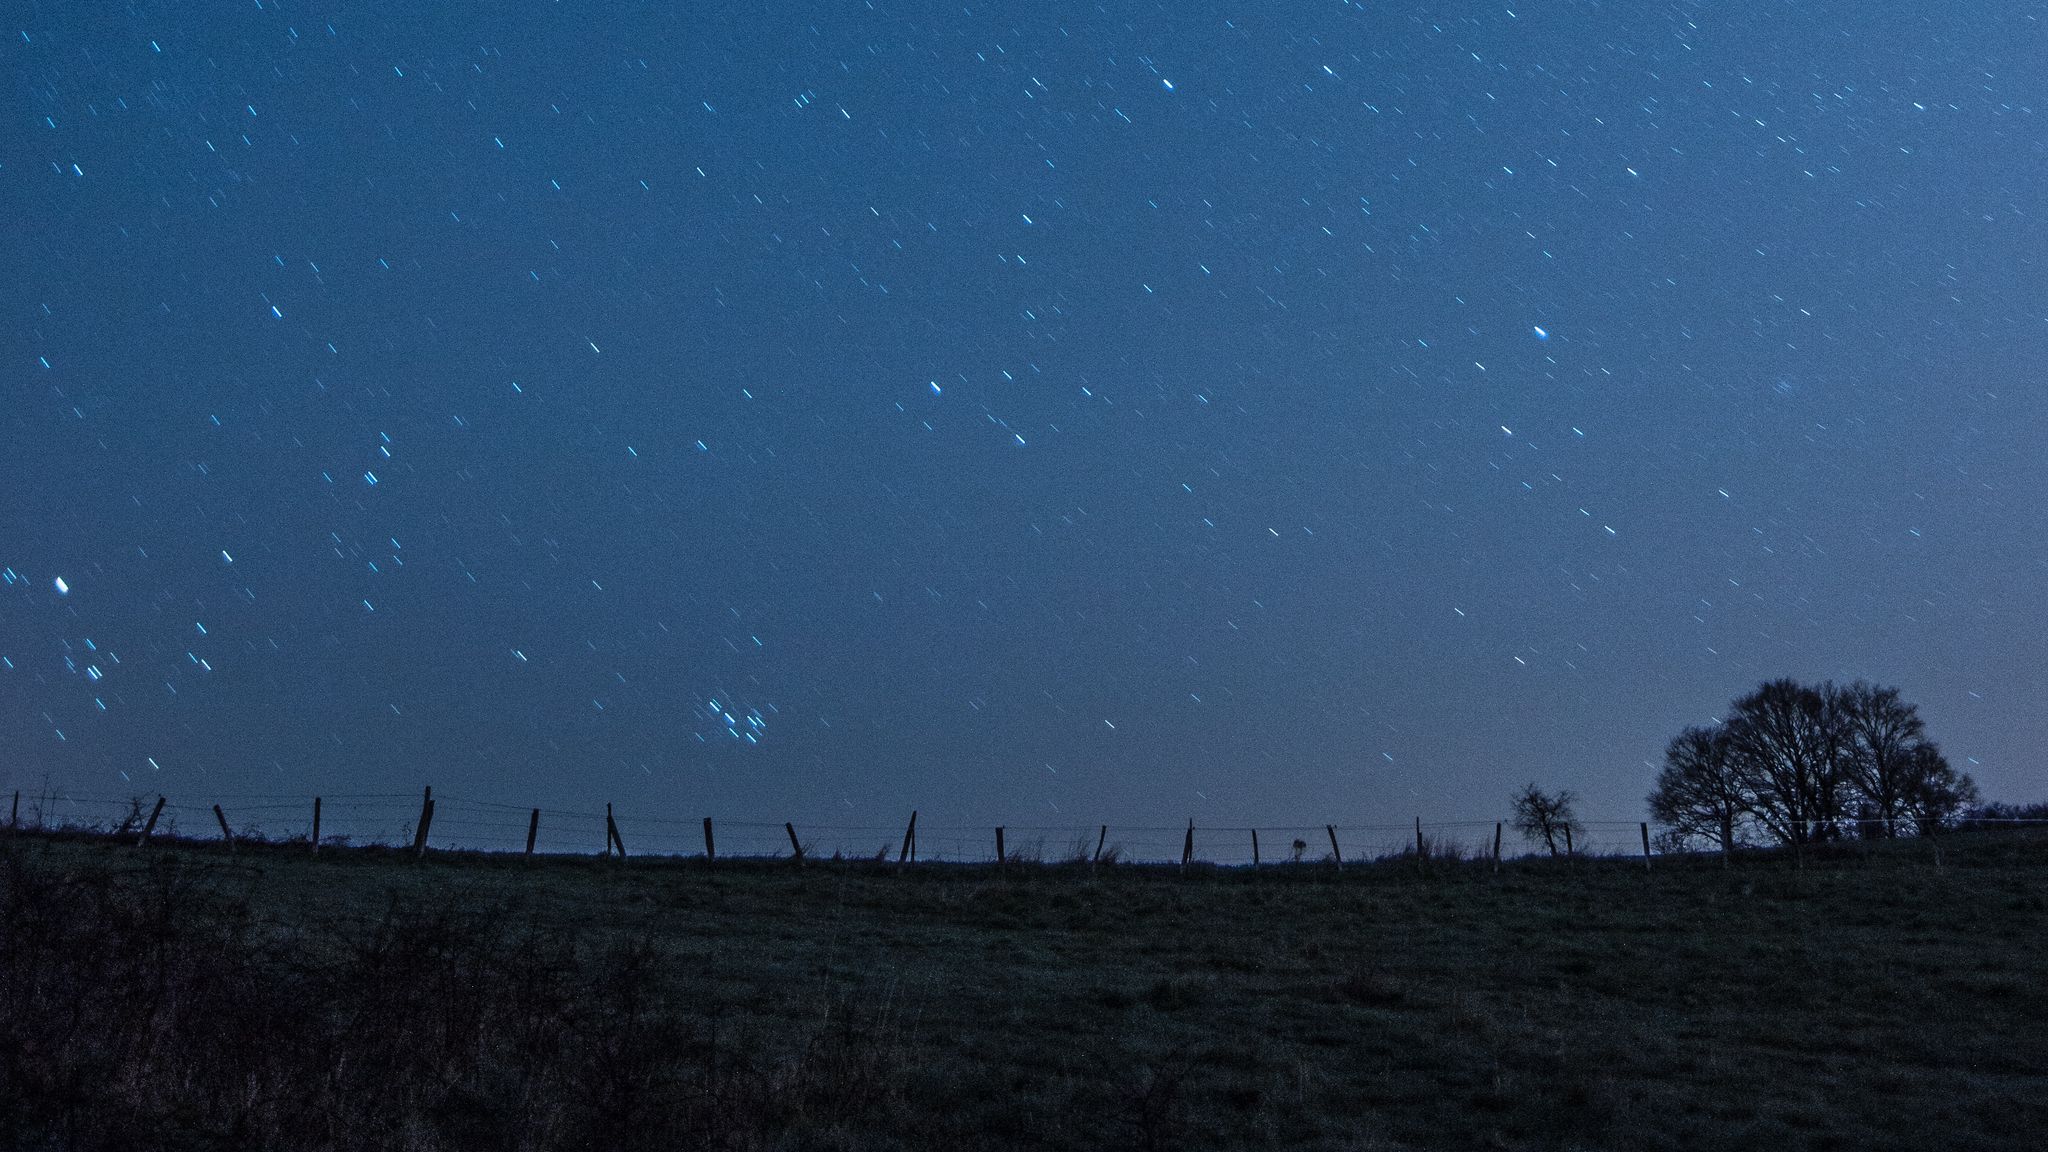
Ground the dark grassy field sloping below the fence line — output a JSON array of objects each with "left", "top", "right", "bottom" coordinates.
[{"left": 0, "top": 819, "right": 2048, "bottom": 1150}]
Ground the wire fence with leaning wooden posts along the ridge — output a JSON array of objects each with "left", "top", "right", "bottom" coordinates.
[{"left": 0, "top": 789, "right": 2048, "bottom": 867}]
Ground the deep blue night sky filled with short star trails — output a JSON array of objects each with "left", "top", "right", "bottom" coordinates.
[{"left": 0, "top": 0, "right": 2048, "bottom": 844}]
